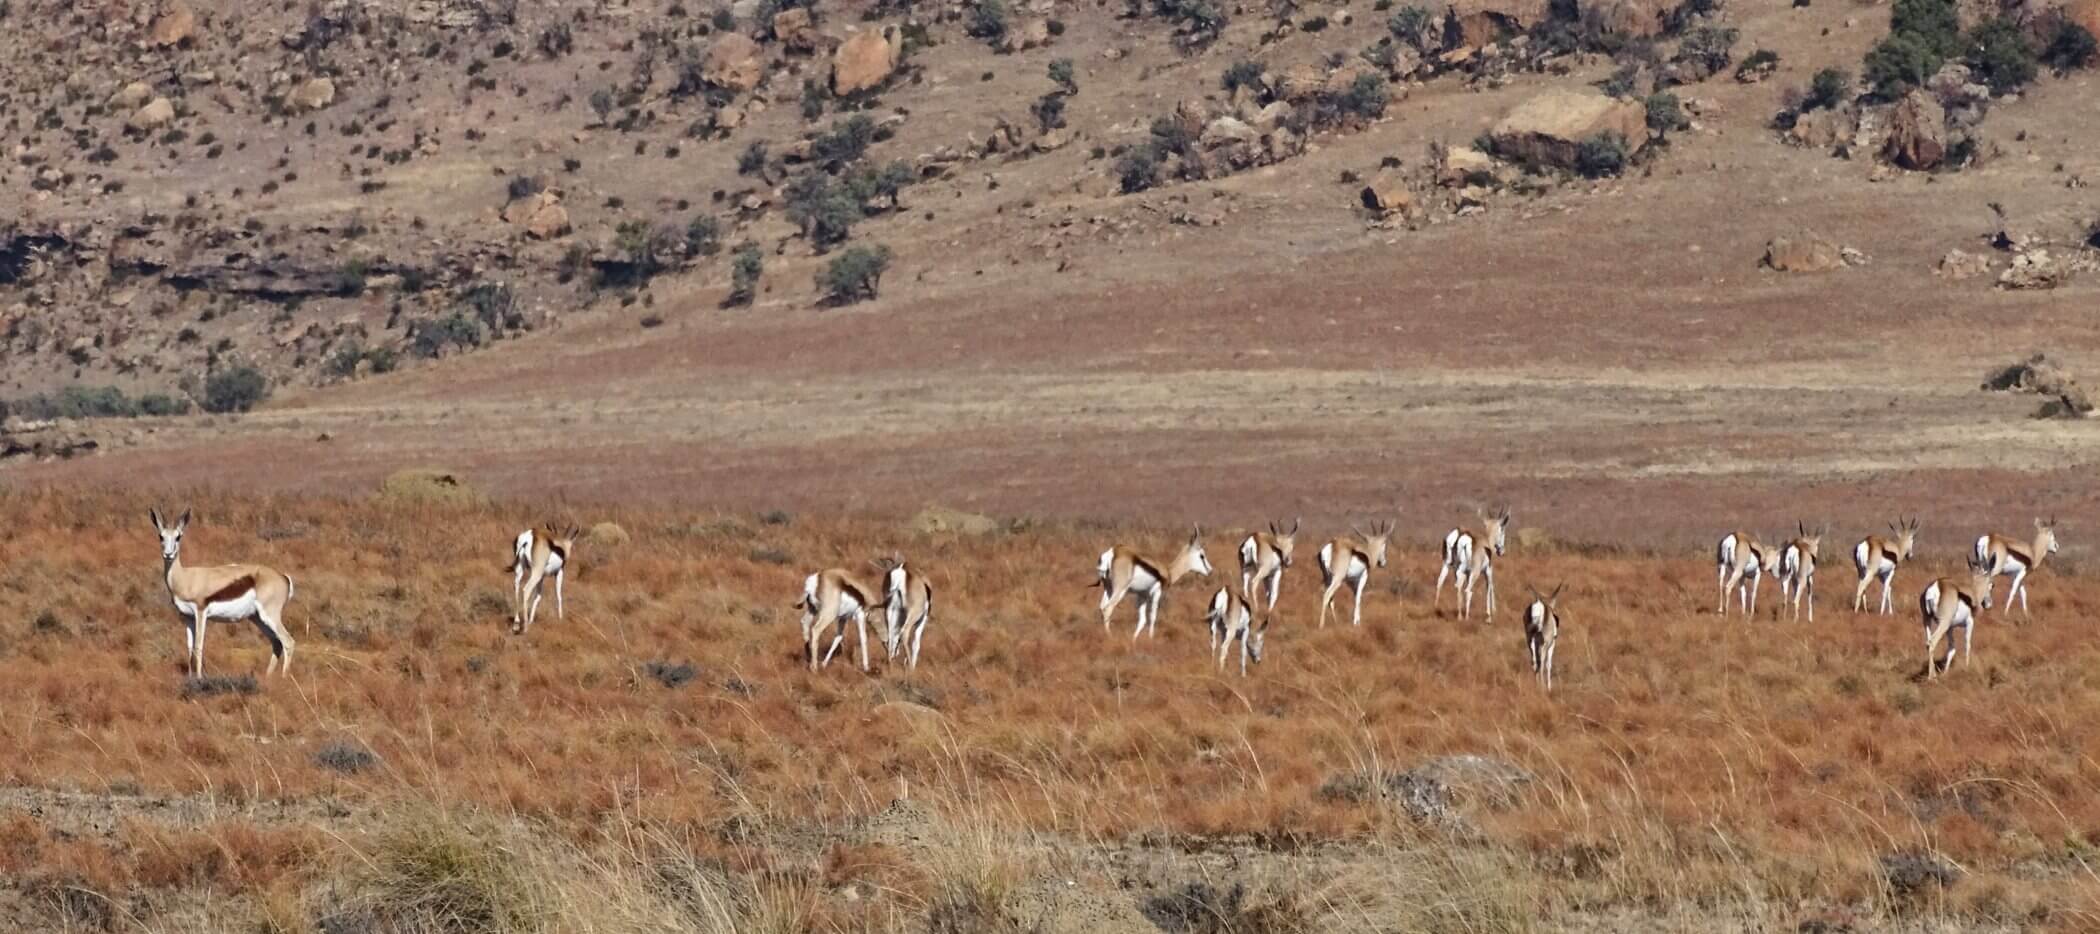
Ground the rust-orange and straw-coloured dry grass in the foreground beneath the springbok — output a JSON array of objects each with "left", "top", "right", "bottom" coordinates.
[{"left": 0, "top": 493, "right": 2100, "bottom": 932}]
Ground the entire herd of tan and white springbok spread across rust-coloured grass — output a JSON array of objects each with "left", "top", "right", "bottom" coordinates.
[{"left": 151, "top": 508, "right": 2058, "bottom": 691}]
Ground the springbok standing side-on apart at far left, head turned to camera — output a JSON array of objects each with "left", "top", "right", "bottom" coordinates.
[{"left": 147, "top": 510, "right": 292, "bottom": 678}]
